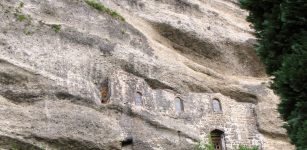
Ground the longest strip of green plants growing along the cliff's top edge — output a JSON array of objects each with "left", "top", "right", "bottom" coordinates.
[{"left": 85, "top": 0, "right": 125, "bottom": 21}]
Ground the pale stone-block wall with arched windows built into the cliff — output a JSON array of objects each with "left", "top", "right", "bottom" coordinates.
[{"left": 108, "top": 71, "right": 263, "bottom": 150}]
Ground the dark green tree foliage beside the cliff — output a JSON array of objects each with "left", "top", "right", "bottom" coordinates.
[{"left": 240, "top": 0, "right": 307, "bottom": 150}]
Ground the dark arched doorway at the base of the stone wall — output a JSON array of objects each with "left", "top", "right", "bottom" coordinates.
[{"left": 210, "top": 129, "right": 226, "bottom": 150}]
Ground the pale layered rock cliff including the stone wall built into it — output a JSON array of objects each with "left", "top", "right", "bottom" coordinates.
[{"left": 0, "top": 0, "right": 294, "bottom": 150}]
